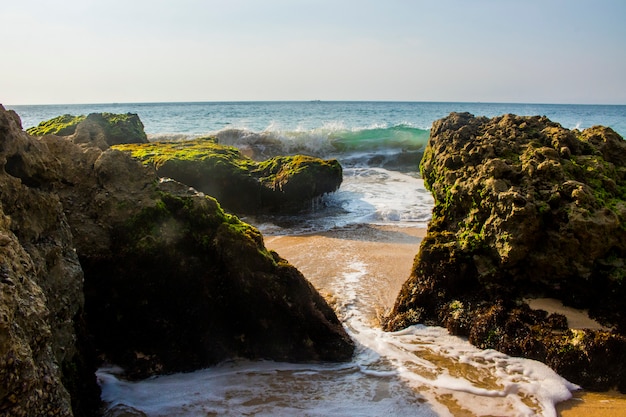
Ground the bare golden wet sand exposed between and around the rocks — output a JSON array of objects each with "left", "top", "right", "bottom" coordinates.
[{"left": 265, "top": 225, "right": 626, "bottom": 417}]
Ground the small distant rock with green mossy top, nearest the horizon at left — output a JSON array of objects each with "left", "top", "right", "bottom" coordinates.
[{"left": 26, "top": 113, "right": 148, "bottom": 149}]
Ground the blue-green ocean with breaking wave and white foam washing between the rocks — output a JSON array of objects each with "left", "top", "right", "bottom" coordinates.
[{"left": 6, "top": 101, "right": 626, "bottom": 417}]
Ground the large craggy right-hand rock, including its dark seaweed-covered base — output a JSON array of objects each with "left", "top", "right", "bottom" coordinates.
[{"left": 386, "top": 113, "right": 626, "bottom": 390}]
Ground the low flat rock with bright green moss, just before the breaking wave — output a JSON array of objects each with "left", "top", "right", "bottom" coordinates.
[{"left": 115, "top": 138, "right": 342, "bottom": 214}]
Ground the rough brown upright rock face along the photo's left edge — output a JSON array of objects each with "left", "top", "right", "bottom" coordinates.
[{"left": 0, "top": 106, "right": 99, "bottom": 416}]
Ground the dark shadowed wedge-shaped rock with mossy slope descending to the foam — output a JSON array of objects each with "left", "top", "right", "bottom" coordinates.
[{"left": 81, "top": 187, "right": 354, "bottom": 378}]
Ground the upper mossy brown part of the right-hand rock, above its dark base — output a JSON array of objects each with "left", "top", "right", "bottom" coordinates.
[{"left": 398, "top": 113, "right": 626, "bottom": 316}]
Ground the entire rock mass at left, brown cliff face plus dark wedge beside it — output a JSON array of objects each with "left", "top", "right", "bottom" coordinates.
[{"left": 0, "top": 106, "right": 354, "bottom": 416}]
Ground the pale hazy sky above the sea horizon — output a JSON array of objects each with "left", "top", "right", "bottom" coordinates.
[{"left": 0, "top": 0, "right": 626, "bottom": 105}]
